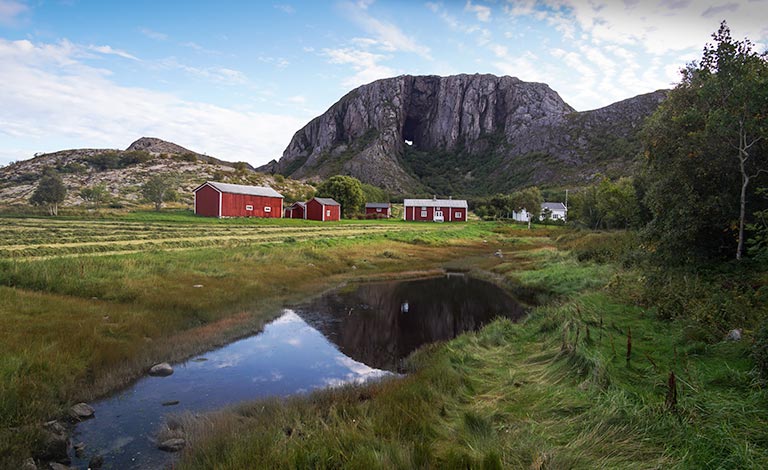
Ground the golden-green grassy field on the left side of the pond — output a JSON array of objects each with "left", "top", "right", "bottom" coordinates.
[{"left": 0, "top": 217, "right": 504, "bottom": 468}]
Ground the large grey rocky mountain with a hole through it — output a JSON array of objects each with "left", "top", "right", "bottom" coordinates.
[{"left": 257, "top": 74, "right": 666, "bottom": 195}]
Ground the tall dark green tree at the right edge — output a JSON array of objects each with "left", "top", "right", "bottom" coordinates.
[{"left": 644, "top": 22, "right": 768, "bottom": 261}]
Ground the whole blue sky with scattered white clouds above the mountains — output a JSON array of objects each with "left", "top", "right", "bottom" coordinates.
[{"left": 0, "top": 0, "right": 768, "bottom": 165}]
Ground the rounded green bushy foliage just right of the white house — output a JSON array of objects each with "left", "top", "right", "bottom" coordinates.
[{"left": 568, "top": 177, "right": 643, "bottom": 230}]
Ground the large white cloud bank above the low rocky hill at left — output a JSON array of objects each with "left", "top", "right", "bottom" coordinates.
[{"left": 0, "top": 39, "right": 306, "bottom": 165}]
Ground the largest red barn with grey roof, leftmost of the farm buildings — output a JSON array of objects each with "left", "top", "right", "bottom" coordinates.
[{"left": 194, "top": 181, "right": 283, "bottom": 218}]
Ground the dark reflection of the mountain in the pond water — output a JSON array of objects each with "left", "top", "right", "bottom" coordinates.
[{"left": 295, "top": 275, "right": 524, "bottom": 371}]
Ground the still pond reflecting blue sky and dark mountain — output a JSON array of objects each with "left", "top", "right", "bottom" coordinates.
[{"left": 71, "top": 274, "right": 524, "bottom": 469}]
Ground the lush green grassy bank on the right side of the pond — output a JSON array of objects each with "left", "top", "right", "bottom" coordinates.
[{"left": 171, "top": 231, "right": 768, "bottom": 469}]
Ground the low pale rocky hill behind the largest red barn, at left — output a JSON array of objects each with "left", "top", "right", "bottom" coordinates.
[{"left": 0, "top": 137, "right": 314, "bottom": 207}]
